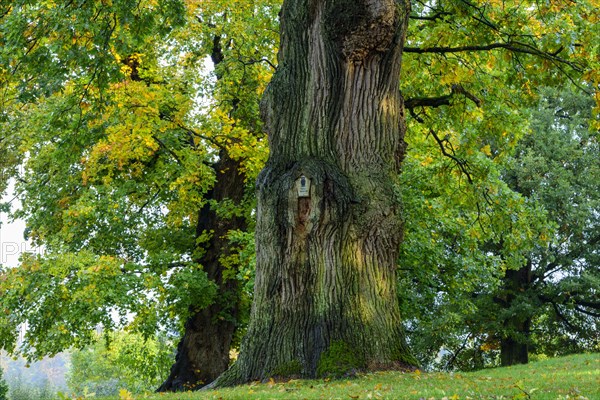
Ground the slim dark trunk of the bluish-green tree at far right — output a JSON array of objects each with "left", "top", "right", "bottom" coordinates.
[{"left": 500, "top": 262, "right": 531, "bottom": 367}]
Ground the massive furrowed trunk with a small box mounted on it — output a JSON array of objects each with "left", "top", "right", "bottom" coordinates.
[{"left": 211, "top": 0, "right": 416, "bottom": 386}]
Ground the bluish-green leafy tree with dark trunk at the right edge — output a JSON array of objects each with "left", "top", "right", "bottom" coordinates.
[{"left": 494, "top": 90, "right": 600, "bottom": 365}]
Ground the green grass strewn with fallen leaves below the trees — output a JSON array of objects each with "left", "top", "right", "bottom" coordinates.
[{"left": 101, "top": 353, "right": 600, "bottom": 400}]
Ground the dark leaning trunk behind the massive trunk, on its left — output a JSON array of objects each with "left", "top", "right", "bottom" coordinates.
[{"left": 158, "top": 152, "right": 246, "bottom": 392}]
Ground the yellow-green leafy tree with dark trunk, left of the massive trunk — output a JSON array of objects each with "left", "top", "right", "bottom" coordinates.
[{"left": 0, "top": 2, "right": 275, "bottom": 390}]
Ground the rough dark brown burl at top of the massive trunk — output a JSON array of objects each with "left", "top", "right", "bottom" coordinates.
[{"left": 323, "top": 0, "right": 398, "bottom": 61}]
